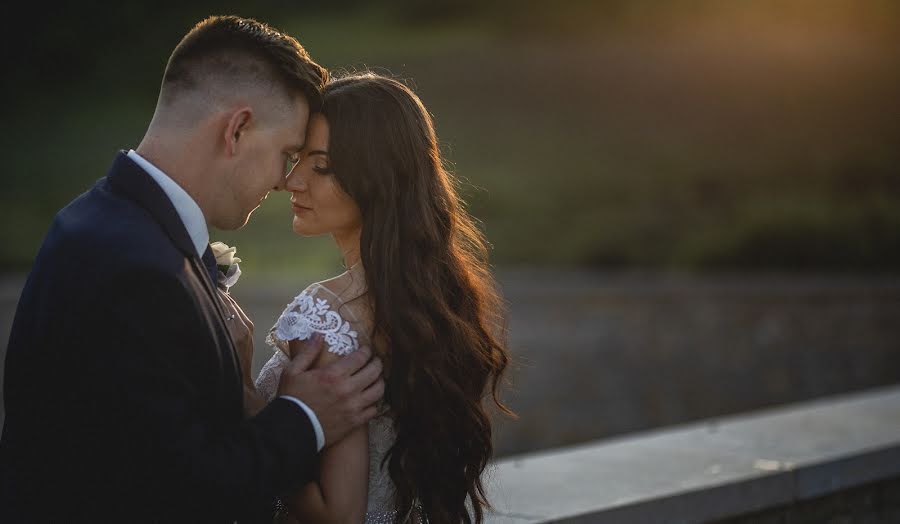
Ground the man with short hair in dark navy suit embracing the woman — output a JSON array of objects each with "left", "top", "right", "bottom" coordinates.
[{"left": 0, "top": 17, "right": 384, "bottom": 522}]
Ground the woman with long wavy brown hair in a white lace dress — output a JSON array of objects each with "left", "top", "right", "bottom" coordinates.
[{"left": 250, "top": 73, "right": 512, "bottom": 524}]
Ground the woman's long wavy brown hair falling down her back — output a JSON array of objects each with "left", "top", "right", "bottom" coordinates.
[{"left": 322, "top": 73, "right": 514, "bottom": 524}]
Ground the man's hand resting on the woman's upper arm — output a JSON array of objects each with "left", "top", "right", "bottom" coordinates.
[{"left": 278, "top": 334, "right": 384, "bottom": 446}]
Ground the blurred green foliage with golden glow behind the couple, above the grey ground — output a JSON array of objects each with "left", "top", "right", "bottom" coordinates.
[{"left": 0, "top": 0, "right": 900, "bottom": 273}]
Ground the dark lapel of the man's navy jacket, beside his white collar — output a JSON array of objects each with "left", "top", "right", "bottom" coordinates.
[{"left": 106, "top": 152, "right": 241, "bottom": 398}]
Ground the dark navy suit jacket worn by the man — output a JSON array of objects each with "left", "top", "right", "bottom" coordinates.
[{"left": 0, "top": 153, "right": 317, "bottom": 522}]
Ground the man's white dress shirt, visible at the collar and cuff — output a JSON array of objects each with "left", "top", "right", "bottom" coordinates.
[{"left": 128, "top": 149, "right": 325, "bottom": 451}]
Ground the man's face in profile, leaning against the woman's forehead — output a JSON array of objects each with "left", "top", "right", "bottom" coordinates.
[{"left": 219, "top": 97, "right": 309, "bottom": 230}]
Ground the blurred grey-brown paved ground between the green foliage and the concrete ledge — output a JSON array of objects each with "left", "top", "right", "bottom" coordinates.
[{"left": 0, "top": 271, "right": 900, "bottom": 456}]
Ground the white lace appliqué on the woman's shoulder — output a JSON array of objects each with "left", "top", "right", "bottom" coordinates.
[{"left": 266, "top": 290, "right": 359, "bottom": 355}]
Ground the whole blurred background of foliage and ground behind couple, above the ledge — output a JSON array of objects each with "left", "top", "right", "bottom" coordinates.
[{"left": 0, "top": 0, "right": 900, "bottom": 456}]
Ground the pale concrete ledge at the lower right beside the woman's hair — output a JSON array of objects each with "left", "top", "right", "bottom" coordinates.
[{"left": 487, "top": 386, "right": 900, "bottom": 523}]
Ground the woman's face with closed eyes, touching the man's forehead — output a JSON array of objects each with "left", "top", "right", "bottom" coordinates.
[{"left": 285, "top": 113, "right": 362, "bottom": 236}]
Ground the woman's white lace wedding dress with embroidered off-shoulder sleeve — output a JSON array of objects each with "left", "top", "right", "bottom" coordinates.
[{"left": 256, "top": 264, "right": 420, "bottom": 524}]
